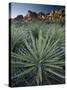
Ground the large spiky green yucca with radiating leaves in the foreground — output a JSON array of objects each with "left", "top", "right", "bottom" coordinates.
[{"left": 11, "top": 21, "right": 65, "bottom": 86}]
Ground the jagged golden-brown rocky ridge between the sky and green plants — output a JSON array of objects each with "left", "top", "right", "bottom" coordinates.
[{"left": 14, "top": 10, "right": 65, "bottom": 22}]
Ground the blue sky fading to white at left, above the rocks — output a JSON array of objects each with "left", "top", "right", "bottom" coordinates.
[{"left": 9, "top": 3, "right": 65, "bottom": 18}]
